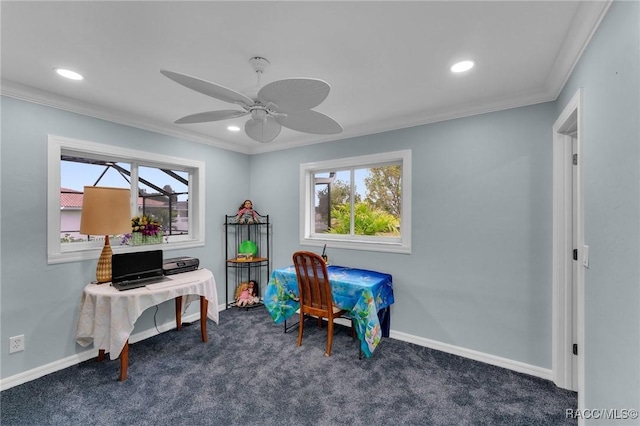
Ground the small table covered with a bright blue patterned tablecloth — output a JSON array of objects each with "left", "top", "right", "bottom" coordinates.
[{"left": 264, "top": 265, "right": 394, "bottom": 357}]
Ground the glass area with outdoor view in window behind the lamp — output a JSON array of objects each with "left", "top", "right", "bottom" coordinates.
[{"left": 60, "top": 155, "right": 189, "bottom": 243}]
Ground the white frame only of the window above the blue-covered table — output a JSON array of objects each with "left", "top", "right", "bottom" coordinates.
[{"left": 300, "top": 150, "right": 411, "bottom": 254}]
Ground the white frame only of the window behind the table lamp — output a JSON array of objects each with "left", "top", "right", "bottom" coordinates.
[{"left": 47, "top": 135, "right": 205, "bottom": 264}]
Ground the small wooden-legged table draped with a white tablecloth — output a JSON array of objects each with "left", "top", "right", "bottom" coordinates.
[{"left": 76, "top": 269, "right": 218, "bottom": 381}]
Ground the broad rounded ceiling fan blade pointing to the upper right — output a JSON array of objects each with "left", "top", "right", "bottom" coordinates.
[{"left": 258, "top": 78, "right": 331, "bottom": 113}]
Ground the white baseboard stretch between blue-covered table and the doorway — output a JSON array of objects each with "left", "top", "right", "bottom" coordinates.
[{"left": 389, "top": 330, "right": 553, "bottom": 380}]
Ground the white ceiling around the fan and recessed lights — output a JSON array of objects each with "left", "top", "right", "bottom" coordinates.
[{"left": 0, "top": 0, "right": 609, "bottom": 153}]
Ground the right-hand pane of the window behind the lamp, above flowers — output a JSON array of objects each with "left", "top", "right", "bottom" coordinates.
[{"left": 138, "top": 166, "right": 189, "bottom": 235}]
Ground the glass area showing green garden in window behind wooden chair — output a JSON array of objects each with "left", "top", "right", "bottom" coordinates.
[{"left": 313, "top": 164, "right": 402, "bottom": 238}]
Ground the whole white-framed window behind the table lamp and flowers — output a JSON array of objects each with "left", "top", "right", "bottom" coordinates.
[{"left": 47, "top": 136, "right": 204, "bottom": 263}]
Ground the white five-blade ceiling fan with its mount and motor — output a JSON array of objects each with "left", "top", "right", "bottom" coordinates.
[{"left": 160, "top": 57, "right": 342, "bottom": 143}]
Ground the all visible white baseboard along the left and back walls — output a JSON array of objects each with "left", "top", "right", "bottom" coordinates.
[{"left": 0, "top": 305, "right": 553, "bottom": 391}]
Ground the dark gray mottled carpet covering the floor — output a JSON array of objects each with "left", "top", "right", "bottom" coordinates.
[{"left": 0, "top": 307, "right": 577, "bottom": 426}]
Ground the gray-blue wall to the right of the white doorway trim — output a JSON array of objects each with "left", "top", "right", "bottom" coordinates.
[{"left": 557, "top": 1, "right": 640, "bottom": 424}]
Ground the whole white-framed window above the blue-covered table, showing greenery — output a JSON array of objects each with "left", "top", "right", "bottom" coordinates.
[{"left": 300, "top": 150, "right": 411, "bottom": 253}]
